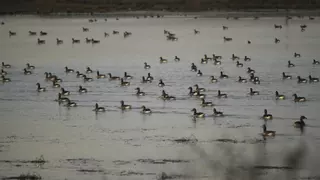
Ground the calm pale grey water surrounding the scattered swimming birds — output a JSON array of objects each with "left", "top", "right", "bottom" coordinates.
[{"left": 0, "top": 17, "right": 320, "bottom": 179}]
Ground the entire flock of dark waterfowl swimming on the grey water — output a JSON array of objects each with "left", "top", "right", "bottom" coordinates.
[{"left": 1, "top": 17, "right": 320, "bottom": 136}]
